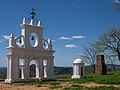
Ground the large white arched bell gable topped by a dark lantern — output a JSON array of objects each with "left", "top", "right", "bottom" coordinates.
[{"left": 5, "top": 11, "right": 55, "bottom": 83}]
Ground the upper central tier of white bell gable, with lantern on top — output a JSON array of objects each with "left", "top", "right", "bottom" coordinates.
[{"left": 21, "top": 10, "right": 43, "bottom": 49}]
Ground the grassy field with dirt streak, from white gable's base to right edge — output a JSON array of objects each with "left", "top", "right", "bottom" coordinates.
[{"left": 17, "top": 72, "right": 120, "bottom": 90}]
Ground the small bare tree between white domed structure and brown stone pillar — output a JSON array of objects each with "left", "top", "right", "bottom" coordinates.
[{"left": 80, "top": 45, "right": 97, "bottom": 73}]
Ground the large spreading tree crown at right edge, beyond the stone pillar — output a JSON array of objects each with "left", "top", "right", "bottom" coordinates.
[{"left": 92, "top": 27, "right": 120, "bottom": 61}]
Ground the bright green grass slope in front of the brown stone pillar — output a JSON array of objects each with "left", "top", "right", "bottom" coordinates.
[{"left": 68, "top": 72, "right": 120, "bottom": 84}]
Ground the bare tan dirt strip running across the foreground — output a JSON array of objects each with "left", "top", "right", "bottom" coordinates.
[{"left": 0, "top": 82, "right": 120, "bottom": 90}]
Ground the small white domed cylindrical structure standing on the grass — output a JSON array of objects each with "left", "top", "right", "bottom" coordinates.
[{"left": 71, "top": 59, "right": 84, "bottom": 78}]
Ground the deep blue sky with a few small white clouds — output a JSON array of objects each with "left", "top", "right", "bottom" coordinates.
[{"left": 0, "top": 0, "right": 120, "bottom": 67}]
